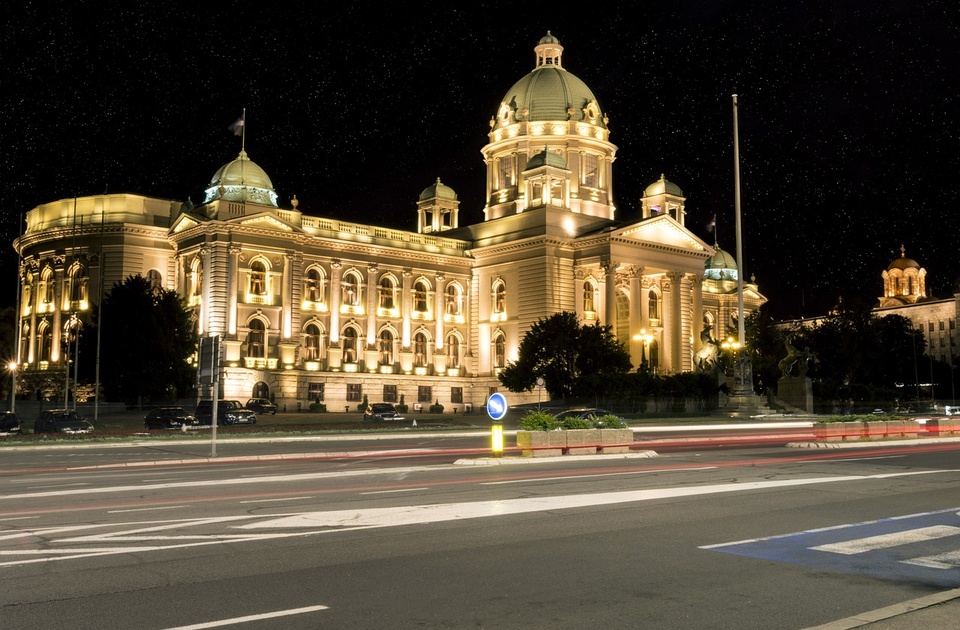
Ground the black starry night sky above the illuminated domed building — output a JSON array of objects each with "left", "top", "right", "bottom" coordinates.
[{"left": 0, "top": 0, "right": 960, "bottom": 318}]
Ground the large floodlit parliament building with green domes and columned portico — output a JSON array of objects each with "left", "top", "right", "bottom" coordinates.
[{"left": 14, "top": 33, "right": 766, "bottom": 410}]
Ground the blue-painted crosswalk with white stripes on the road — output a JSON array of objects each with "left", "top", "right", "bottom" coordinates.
[{"left": 700, "top": 508, "right": 960, "bottom": 588}]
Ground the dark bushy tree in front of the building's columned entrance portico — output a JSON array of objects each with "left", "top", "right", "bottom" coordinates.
[{"left": 499, "top": 311, "right": 633, "bottom": 399}]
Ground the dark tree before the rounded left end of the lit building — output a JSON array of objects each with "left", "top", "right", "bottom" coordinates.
[{"left": 81, "top": 275, "right": 198, "bottom": 405}]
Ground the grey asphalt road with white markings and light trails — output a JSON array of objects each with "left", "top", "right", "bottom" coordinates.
[{"left": 0, "top": 432, "right": 960, "bottom": 630}]
